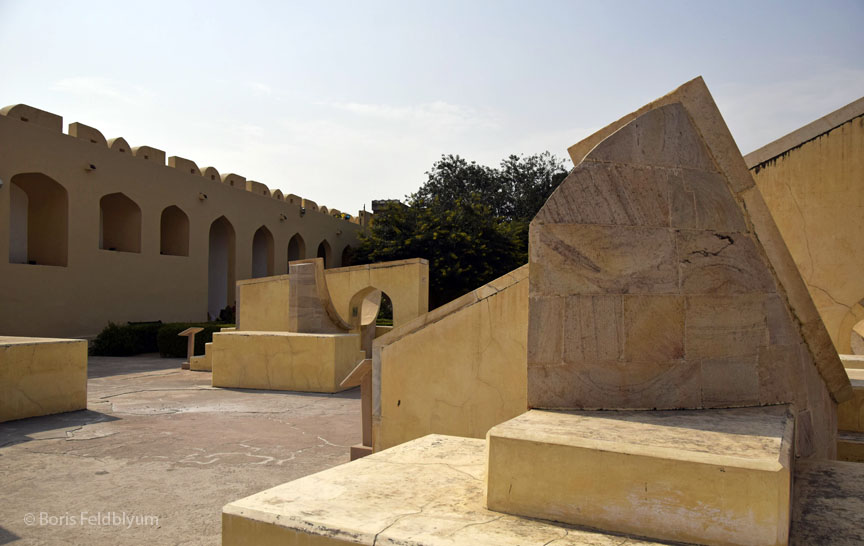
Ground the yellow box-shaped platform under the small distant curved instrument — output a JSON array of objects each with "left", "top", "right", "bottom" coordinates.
[{"left": 208, "top": 331, "right": 365, "bottom": 393}]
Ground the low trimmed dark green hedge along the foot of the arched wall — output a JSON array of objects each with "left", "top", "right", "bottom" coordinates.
[{"left": 90, "top": 321, "right": 234, "bottom": 358}]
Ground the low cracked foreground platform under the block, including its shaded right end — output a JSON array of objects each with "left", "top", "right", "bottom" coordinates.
[{"left": 222, "top": 435, "right": 864, "bottom": 546}]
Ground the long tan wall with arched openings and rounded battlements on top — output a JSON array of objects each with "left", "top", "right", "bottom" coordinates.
[{"left": 0, "top": 105, "right": 367, "bottom": 338}]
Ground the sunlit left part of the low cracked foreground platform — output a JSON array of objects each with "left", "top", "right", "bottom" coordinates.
[{"left": 222, "top": 435, "right": 666, "bottom": 546}]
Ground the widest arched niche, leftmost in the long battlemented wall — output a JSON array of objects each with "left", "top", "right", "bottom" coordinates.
[{"left": 9, "top": 173, "right": 69, "bottom": 266}]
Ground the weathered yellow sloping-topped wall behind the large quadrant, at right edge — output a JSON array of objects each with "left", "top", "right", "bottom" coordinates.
[{"left": 745, "top": 99, "right": 864, "bottom": 354}]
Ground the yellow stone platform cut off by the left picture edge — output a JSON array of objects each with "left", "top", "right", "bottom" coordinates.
[{"left": 0, "top": 336, "right": 87, "bottom": 422}]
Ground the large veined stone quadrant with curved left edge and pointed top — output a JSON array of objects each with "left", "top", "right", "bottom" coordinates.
[{"left": 528, "top": 80, "right": 849, "bottom": 456}]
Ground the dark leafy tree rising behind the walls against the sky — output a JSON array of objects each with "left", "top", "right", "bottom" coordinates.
[{"left": 354, "top": 152, "right": 567, "bottom": 308}]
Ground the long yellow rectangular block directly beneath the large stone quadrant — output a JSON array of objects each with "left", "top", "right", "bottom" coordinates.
[{"left": 486, "top": 406, "right": 794, "bottom": 546}]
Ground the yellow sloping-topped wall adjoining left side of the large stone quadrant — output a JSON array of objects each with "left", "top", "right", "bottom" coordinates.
[{"left": 373, "top": 265, "right": 528, "bottom": 451}]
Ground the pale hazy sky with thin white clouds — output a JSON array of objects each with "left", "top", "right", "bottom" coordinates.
[{"left": 0, "top": 0, "right": 864, "bottom": 213}]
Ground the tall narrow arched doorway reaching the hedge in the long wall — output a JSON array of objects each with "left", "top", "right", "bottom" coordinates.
[{"left": 207, "top": 216, "right": 236, "bottom": 319}]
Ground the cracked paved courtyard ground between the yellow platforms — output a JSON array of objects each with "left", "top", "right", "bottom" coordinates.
[{"left": 0, "top": 355, "right": 360, "bottom": 545}]
